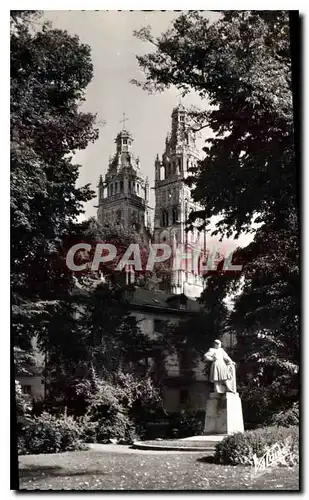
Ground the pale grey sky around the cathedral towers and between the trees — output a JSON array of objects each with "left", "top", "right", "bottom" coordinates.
[{"left": 44, "top": 10, "right": 253, "bottom": 252}]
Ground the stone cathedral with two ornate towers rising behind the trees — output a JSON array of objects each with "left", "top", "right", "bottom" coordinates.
[{"left": 97, "top": 104, "right": 206, "bottom": 297}]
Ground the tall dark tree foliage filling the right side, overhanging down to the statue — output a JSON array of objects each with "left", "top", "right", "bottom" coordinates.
[{"left": 135, "top": 11, "right": 300, "bottom": 418}]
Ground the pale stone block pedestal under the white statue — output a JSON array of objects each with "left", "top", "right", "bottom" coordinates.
[{"left": 204, "top": 392, "right": 244, "bottom": 434}]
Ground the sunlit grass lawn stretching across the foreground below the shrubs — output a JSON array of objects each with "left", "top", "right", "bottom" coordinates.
[{"left": 19, "top": 447, "right": 299, "bottom": 490}]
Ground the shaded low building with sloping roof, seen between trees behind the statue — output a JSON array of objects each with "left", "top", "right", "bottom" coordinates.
[{"left": 125, "top": 287, "right": 212, "bottom": 413}]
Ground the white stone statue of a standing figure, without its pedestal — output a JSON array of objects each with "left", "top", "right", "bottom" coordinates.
[{"left": 204, "top": 340, "right": 236, "bottom": 394}]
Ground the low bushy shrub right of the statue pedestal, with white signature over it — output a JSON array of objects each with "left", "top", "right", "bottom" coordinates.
[{"left": 215, "top": 426, "right": 298, "bottom": 465}]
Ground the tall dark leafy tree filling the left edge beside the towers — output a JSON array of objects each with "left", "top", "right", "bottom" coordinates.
[{"left": 11, "top": 11, "right": 97, "bottom": 354}]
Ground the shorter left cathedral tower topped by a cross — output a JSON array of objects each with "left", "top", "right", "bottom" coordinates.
[{"left": 97, "top": 123, "right": 149, "bottom": 232}]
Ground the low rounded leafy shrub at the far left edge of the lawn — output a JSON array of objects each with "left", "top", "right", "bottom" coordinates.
[{"left": 18, "top": 412, "right": 83, "bottom": 455}]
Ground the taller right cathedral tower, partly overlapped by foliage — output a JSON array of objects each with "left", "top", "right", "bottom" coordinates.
[{"left": 154, "top": 104, "right": 206, "bottom": 297}]
